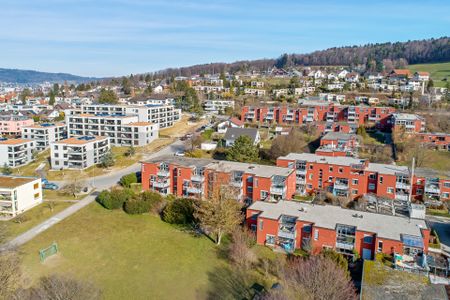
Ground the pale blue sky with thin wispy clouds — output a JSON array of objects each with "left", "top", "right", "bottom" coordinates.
[{"left": 0, "top": 0, "right": 450, "bottom": 76}]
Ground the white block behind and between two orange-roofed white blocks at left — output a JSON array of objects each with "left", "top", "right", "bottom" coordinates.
[{"left": 22, "top": 123, "right": 67, "bottom": 151}]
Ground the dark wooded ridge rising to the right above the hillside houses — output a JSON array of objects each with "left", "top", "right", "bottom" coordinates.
[{"left": 152, "top": 37, "right": 450, "bottom": 76}]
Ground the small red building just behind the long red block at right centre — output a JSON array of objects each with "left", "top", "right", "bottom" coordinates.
[{"left": 316, "top": 132, "right": 359, "bottom": 156}]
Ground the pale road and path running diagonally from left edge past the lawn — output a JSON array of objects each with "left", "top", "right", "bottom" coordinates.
[{"left": 0, "top": 140, "right": 185, "bottom": 251}]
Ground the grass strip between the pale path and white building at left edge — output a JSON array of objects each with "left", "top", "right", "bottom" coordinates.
[{"left": 4, "top": 202, "right": 73, "bottom": 239}]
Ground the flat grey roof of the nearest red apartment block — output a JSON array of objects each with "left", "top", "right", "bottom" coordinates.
[{"left": 248, "top": 201, "right": 428, "bottom": 241}]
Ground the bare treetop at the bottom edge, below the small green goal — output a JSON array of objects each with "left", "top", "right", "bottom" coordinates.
[{"left": 32, "top": 274, "right": 102, "bottom": 300}]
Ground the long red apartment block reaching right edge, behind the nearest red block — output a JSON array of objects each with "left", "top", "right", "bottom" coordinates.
[{"left": 277, "top": 153, "right": 450, "bottom": 201}]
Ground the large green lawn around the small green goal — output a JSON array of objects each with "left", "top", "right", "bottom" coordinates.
[{"left": 20, "top": 203, "right": 229, "bottom": 299}]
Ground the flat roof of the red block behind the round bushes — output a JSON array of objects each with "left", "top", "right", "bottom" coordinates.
[{"left": 144, "top": 156, "right": 294, "bottom": 178}]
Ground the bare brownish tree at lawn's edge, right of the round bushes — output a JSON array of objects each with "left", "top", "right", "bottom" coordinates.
[{"left": 194, "top": 193, "right": 242, "bottom": 245}]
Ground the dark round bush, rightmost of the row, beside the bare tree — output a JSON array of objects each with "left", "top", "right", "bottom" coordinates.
[{"left": 163, "top": 198, "right": 195, "bottom": 225}]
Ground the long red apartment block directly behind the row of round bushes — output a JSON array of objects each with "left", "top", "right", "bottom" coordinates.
[{"left": 142, "top": 156, "right": 295, "bottom": 203}]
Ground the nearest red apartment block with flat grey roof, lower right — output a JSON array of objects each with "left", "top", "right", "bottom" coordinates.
[{"left": 246, "top": 201, "right": 430, "bottom": 259}]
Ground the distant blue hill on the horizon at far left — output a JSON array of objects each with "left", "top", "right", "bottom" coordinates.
[{"left": 0, "top": 68, "right": 98, "bottom": 84}]
